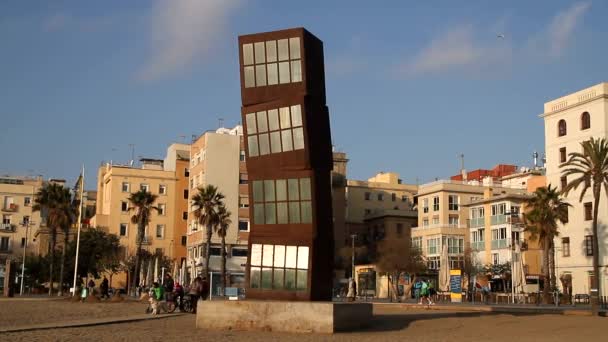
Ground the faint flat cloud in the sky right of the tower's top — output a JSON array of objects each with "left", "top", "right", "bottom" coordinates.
[{"left": 401, "top": 25, "right": 511, "bottom": 74}]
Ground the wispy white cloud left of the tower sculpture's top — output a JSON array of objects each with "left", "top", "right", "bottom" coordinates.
[{"left": 138, "top": 0, "right": 239, "bottom": 80}]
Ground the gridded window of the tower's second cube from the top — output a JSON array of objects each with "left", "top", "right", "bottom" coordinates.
[{"left": 245, "top": 104, "right": 304, "bottom": 157}]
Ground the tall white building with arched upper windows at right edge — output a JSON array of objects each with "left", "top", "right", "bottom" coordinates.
[{"left": 540, "top": 82, "right": 608, "bottom": 296}]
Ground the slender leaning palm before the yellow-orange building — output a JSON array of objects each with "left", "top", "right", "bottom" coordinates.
[{"left": 129, "top": 189, "right": 160, "bottom": 291}]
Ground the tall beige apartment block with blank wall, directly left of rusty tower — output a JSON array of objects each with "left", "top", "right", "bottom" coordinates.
[{"left": 184, "top": 125, "right": 249, "bottom": 294}]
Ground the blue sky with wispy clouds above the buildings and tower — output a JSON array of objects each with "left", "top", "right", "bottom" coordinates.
[{"left": 0, "top": 0, "right": 608, "bottom": 189}]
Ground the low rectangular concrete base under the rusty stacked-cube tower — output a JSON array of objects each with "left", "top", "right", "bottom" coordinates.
[{"left": 196, "top": 300, "right": 373, "bottom": 334}]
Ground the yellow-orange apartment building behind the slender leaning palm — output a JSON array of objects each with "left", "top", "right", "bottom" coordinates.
[{"left": 90, "top": 144, "right": 190, "bottom": 286}]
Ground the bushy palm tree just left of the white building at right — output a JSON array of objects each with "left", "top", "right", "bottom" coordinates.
[{"left": 524, "top": 184, "right": 570, "bottom": 303}]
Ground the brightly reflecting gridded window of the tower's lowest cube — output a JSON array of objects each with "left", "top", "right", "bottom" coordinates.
[{"left": 249, "top": 244, "right": 309, "bottom": 291}]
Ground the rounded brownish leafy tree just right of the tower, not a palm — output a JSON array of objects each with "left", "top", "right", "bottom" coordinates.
[{"left": 376, "top": 239, "right": 426, "bottom": 301}]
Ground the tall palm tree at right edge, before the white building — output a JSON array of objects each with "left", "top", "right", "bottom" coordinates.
[{"left": 561, "top": 138, "right": 608, "bottom": 315}]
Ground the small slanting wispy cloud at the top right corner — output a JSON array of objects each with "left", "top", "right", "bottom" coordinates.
[{"left": 547, "top": 2, "right": 591, "bottom": 57}]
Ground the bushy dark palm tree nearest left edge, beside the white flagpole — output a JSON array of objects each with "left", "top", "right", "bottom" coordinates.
[{"left": 32, "top": 183, "right": 70, "bottom": 296}]
